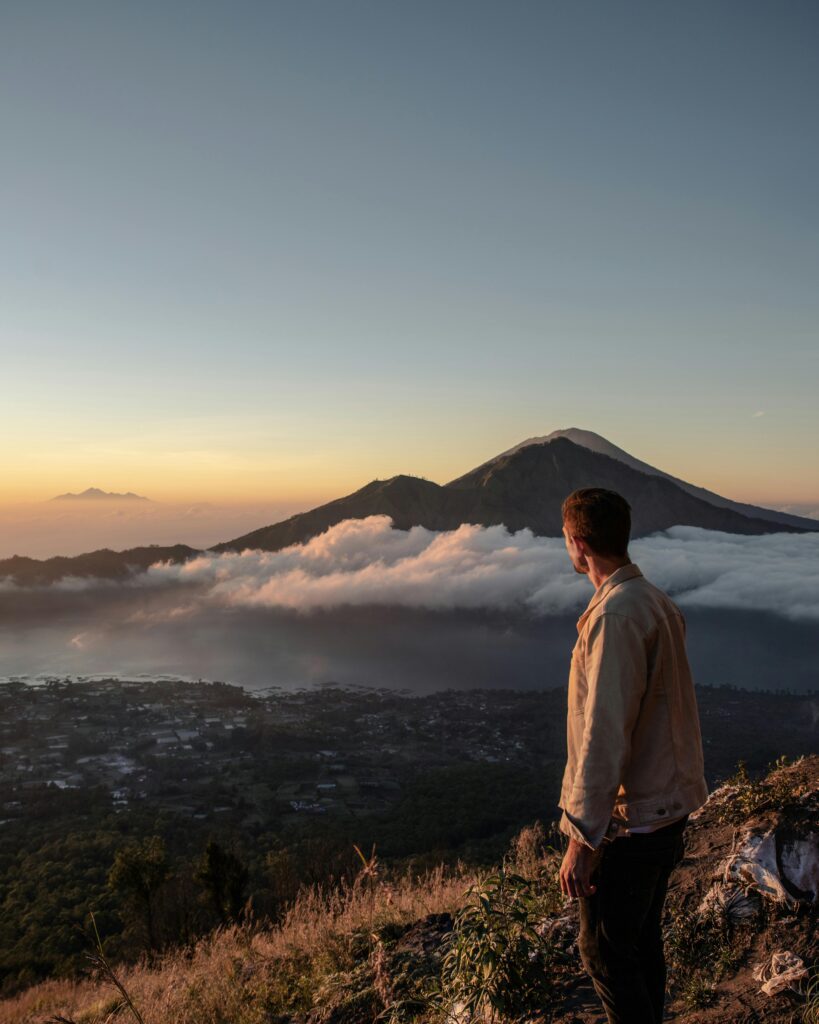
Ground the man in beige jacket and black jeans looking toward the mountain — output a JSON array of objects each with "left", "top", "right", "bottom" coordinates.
[{"left": 559, "top": 487, "right": 708, "bottom": 1024}]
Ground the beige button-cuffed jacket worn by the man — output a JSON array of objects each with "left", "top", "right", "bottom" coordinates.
[{"left": 559, "top": 563, "right": 708, "bottom": 849}]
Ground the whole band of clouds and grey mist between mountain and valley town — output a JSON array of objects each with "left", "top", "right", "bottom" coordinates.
[{"left": 0, "top": 516, "right": 819, "bottom": 692}]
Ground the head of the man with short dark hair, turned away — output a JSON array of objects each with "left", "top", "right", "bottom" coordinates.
[{"left": 562, "top": 487, "right": 632, "bottom": 573}]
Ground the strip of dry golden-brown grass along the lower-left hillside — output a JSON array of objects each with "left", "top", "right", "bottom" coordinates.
[{"left": 0, "top": 858, "right": 487, "bottom": 1024}]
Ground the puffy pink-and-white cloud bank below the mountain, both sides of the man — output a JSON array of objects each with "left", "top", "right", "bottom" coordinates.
[{"left": 121, "top": 515, "right": 819, "bottom": 621}]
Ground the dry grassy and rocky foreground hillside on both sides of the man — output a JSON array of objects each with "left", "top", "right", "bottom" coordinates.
[{"left": 0, "top": 755, "right": 819, "bottom": 1024}]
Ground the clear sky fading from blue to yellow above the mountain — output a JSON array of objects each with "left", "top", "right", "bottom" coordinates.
[{"left": 0, "top": 0, "right": 819, "bottom": 507}]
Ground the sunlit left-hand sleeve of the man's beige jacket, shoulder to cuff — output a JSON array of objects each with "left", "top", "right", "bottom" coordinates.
[{"left": 559, "top": 612, "right": 648, "bottom": 849}]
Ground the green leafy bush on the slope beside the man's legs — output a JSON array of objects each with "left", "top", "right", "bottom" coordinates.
[{"left": 440, "top": 867, "right": 558, "bottom": 1021}]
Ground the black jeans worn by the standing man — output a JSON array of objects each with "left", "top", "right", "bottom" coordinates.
[{"left": 577, "top": 815, "right": 688, "bottom": 1024}]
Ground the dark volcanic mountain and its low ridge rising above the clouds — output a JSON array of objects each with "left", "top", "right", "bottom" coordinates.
[{"left": 0, "top": 427, "right": 819, "bottom": 585}]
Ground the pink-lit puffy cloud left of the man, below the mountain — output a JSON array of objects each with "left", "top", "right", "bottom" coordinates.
[{"left": 137, "top": 515, "right": 585, "bottom": 613}]
